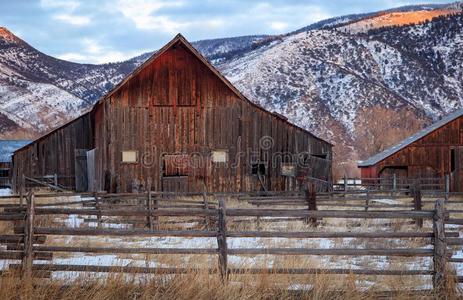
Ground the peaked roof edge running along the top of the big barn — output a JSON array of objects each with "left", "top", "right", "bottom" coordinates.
[{"left": 14, "top": 33, "right": 333, "bottom": 153}]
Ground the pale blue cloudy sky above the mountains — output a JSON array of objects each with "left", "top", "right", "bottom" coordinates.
[{"left": 0, "top": 0, "right": 456, "bottom": 63}]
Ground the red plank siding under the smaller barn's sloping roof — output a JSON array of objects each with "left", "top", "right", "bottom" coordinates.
[{"left": 362, "top": 117, "right": 463, "bottom": 191}]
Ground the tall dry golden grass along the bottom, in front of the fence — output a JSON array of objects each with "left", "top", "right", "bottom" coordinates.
[{"left": 0, "top": 272, "right": 457, "bottom": 300}]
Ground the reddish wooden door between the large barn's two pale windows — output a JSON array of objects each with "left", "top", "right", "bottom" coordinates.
[{"left": 162, "top": 154, "right": 189, "bottom": 193}]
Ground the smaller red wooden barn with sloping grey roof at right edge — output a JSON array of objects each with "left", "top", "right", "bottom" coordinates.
[{"left": 358, "top": 110, "right": 463, "bottom": 191}]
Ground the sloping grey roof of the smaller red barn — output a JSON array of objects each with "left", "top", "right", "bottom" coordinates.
[{"left": 358, "top": 109, "right": 463, "bottom": 168}]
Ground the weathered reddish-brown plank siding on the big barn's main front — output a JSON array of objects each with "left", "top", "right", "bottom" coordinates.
[{"left": 95, "top": 43, "right": 331, "bottom": 191}]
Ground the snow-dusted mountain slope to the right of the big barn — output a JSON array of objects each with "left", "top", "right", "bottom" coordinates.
[{"left": 218, "top": 15, "right": 463, "bottom": 169}]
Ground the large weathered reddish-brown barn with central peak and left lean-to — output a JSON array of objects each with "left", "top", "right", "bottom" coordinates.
[{"left": 13, "top": 35, "right": 332, "bottom": 192}]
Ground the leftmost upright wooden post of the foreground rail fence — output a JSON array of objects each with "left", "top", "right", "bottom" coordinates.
[{"left": 22, "top": 192, "right": 35, "bottom": 280}]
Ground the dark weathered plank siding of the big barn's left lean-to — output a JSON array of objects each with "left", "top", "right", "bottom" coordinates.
[{"left": 13, "top": 114, "right": 93, "bottom": 187}]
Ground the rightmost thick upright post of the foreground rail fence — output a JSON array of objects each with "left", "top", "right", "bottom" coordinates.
[{"left": 432, "top": 200, "right": 447, "bottom": 299}]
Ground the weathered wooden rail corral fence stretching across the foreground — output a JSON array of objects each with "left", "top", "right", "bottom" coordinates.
[{"left": 0, "top": 187, "right": 463, "bottom": 293}]
